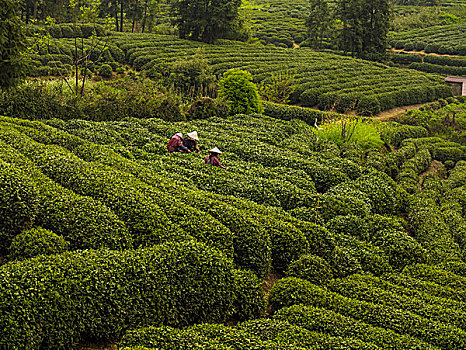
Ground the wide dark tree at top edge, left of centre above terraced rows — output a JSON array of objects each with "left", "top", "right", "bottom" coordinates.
[{"left": 171, "top": 0, "right": 241, "bottom": 43}]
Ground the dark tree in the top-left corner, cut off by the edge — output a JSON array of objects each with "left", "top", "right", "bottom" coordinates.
[{"left": 0, "top": 0, "right": 26, "bottom": 88}]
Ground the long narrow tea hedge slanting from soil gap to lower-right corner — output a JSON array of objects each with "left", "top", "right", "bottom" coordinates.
[{"left": 268, "top": 277, "right": 466, "bottom": 349}]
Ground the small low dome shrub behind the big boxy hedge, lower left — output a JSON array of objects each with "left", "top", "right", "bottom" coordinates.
[{"left": 8, "top": 227, "right": 69, "bottom": 260}]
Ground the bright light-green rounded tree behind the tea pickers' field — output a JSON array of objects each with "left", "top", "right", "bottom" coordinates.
[{"left": 218, "top": 69, "right": 263, "bottom": 114}]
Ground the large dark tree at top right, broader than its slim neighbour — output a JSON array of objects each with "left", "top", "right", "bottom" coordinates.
[{"left": 337, "top": 0, "right": 392, "bottom": 57}]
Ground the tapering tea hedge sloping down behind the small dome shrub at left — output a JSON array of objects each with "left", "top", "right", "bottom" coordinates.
[{"left": 0, "top": 134, "right": 133, "bottom": 250}]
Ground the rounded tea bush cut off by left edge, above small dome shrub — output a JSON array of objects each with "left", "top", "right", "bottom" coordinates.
[{"left": 0, "top": 160, "right": 39, "bottom": 252}]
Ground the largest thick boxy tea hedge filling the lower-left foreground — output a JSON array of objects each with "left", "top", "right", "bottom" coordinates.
[{"left": 0, "top": 242, "right": 240, "bottom": 349}]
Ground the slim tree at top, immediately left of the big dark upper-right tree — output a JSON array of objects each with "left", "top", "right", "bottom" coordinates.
[{"left": 306, "top": 0, "right": 333, "bottom": 49}]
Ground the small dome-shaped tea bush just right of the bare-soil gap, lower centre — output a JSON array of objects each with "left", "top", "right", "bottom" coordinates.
[{"left": 286, "top": 254, "right": 333, "bottom": 285}]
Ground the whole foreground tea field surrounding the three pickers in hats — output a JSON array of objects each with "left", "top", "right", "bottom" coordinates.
[{"left": 0, "top": 98, "right": 466, "bottom": 350}]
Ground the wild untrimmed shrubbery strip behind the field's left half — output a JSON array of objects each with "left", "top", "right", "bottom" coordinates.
[{"left": 0, "top": 80, "right": 185, "bottom": 121}]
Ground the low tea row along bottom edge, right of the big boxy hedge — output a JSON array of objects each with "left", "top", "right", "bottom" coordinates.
[{"left": 120, "top": 319, "right": 379, "bottom": 350}]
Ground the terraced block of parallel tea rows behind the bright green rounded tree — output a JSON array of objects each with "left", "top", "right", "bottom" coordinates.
[{"left": 111, "top": 34, "right": 452, "bottom": 115}]
